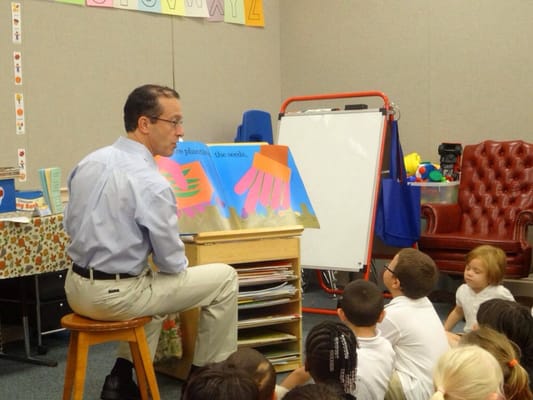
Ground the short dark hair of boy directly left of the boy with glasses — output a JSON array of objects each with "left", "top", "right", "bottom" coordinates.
[{"left": 339, "top": 279, "right": 384, "bottom": 326}]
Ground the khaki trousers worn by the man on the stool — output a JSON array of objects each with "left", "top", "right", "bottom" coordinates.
[{"left": 65, "top": 264, "right": 238, "bottom": 365}]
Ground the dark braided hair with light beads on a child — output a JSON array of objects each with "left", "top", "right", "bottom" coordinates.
[{"left": 305, "top": 320, "right": 357, "bottom": 393}]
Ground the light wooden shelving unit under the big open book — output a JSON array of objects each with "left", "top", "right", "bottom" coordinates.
[{"left": 156, "top": 226, "right": 303, "bottom": 379}]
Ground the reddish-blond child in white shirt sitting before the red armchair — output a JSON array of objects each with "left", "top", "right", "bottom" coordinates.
[{"left": 444, "top": 245, "right": 514, "bottom": 344}]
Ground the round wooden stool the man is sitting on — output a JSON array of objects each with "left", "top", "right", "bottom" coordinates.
[{"left": 61, "top": 313, "right": 160, "bottom": 400}]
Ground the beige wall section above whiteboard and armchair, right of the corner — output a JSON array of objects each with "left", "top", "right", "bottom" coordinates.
[{"left": 280, "top": 0, "right": 533, "bottom": 161}]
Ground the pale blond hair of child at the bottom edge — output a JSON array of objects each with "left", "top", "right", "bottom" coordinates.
[{"left": 430, "top": 346, "right": 503, "bottom": 400}]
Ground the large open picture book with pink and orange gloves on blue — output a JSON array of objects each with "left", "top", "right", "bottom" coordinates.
[{"left": 156, "top": 141, "right": 319, "bottom": 234}]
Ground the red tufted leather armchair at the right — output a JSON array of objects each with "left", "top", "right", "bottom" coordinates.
[{"left": 418, "top": 140, "right": 533, "bottom": 278}]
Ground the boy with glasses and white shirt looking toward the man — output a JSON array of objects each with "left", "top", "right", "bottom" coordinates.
[{"left": 377, "top": 248, "right": 449, "bottom": 400}]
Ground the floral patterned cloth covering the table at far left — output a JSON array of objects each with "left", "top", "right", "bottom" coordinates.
[{"left": 0, "top": 214, "right": 71, "bottom": 279}]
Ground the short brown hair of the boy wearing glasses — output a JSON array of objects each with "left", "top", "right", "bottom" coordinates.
[{"left": 394, "top": 248, "right": 438, "bottom": 300}]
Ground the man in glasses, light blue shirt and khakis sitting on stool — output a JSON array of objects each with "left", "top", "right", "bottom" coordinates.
[{"left": 64, "top": 85, "right": 238, "bottom": 400}]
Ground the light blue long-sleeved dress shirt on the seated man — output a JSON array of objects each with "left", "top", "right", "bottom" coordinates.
[{"left": 63, "top": 137, "right": 188, "bottom": 275}]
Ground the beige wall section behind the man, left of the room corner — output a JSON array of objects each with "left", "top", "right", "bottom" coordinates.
[{"left": 0, "top": 0, "right": 281, "bottom": 189}]
